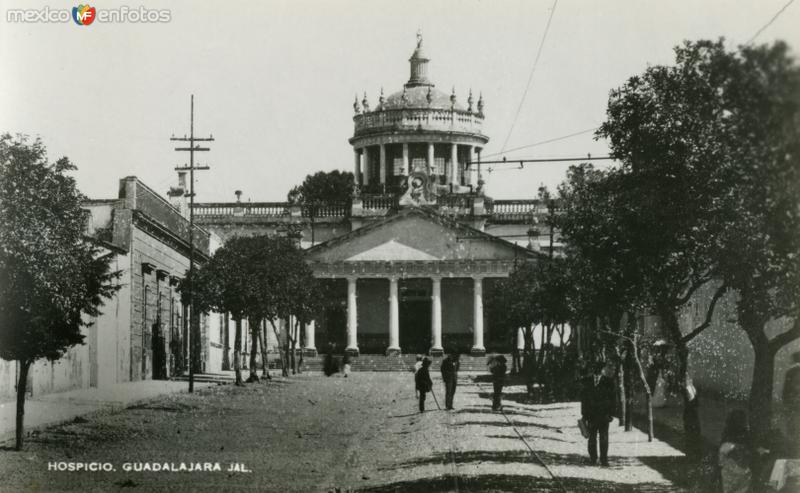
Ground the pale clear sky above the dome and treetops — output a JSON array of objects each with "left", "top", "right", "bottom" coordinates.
[{"left": 0, "top": 0, "right": 800, "bottom": 202}]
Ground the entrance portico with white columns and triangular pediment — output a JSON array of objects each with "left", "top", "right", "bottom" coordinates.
[{"left": 307, "top": 208, "right": 535, "bottom": 355}]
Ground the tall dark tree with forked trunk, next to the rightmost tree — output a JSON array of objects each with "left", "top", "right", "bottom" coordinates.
[{"left": 598, "top": 41, "right": 760, "bottom": 455}]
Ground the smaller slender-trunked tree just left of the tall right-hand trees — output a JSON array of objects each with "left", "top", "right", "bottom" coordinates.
[{"left": 558, "top": 164, "right": 653, "bottom": 440}]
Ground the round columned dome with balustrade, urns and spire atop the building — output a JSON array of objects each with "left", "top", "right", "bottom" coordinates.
[{"left": 350, "top": 34, "right": 489, "bottom": 205}]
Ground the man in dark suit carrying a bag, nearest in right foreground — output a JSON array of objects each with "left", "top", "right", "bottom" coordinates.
[{"left": 581, "top": 361, "right": 616, "bottom": 466}]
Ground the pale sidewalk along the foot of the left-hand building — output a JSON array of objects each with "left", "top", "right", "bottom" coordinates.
[{"left": 0, "top": 380, "right": 216, "bottom": 444}]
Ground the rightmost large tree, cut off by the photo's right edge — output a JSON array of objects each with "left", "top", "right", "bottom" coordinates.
[{"left": 717, "top": 42, "right": 800, "bottom": 436}]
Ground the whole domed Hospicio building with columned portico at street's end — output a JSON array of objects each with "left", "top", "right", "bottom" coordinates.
[{"left": 194, "top": 34, "right": 552, "bottom": 360}]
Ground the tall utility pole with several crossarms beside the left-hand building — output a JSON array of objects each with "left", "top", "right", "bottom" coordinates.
[{"left": 169, "top": 94, "right": 214, "bottom": 392}]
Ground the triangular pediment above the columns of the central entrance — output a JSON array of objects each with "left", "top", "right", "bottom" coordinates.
[{"left": 307, "top": 208, "right": 534, "bottom": 262}]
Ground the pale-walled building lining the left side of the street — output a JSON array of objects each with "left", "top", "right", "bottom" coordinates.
[{"left": 0, "top": 176, "right": 214, "bottom": 398}]
